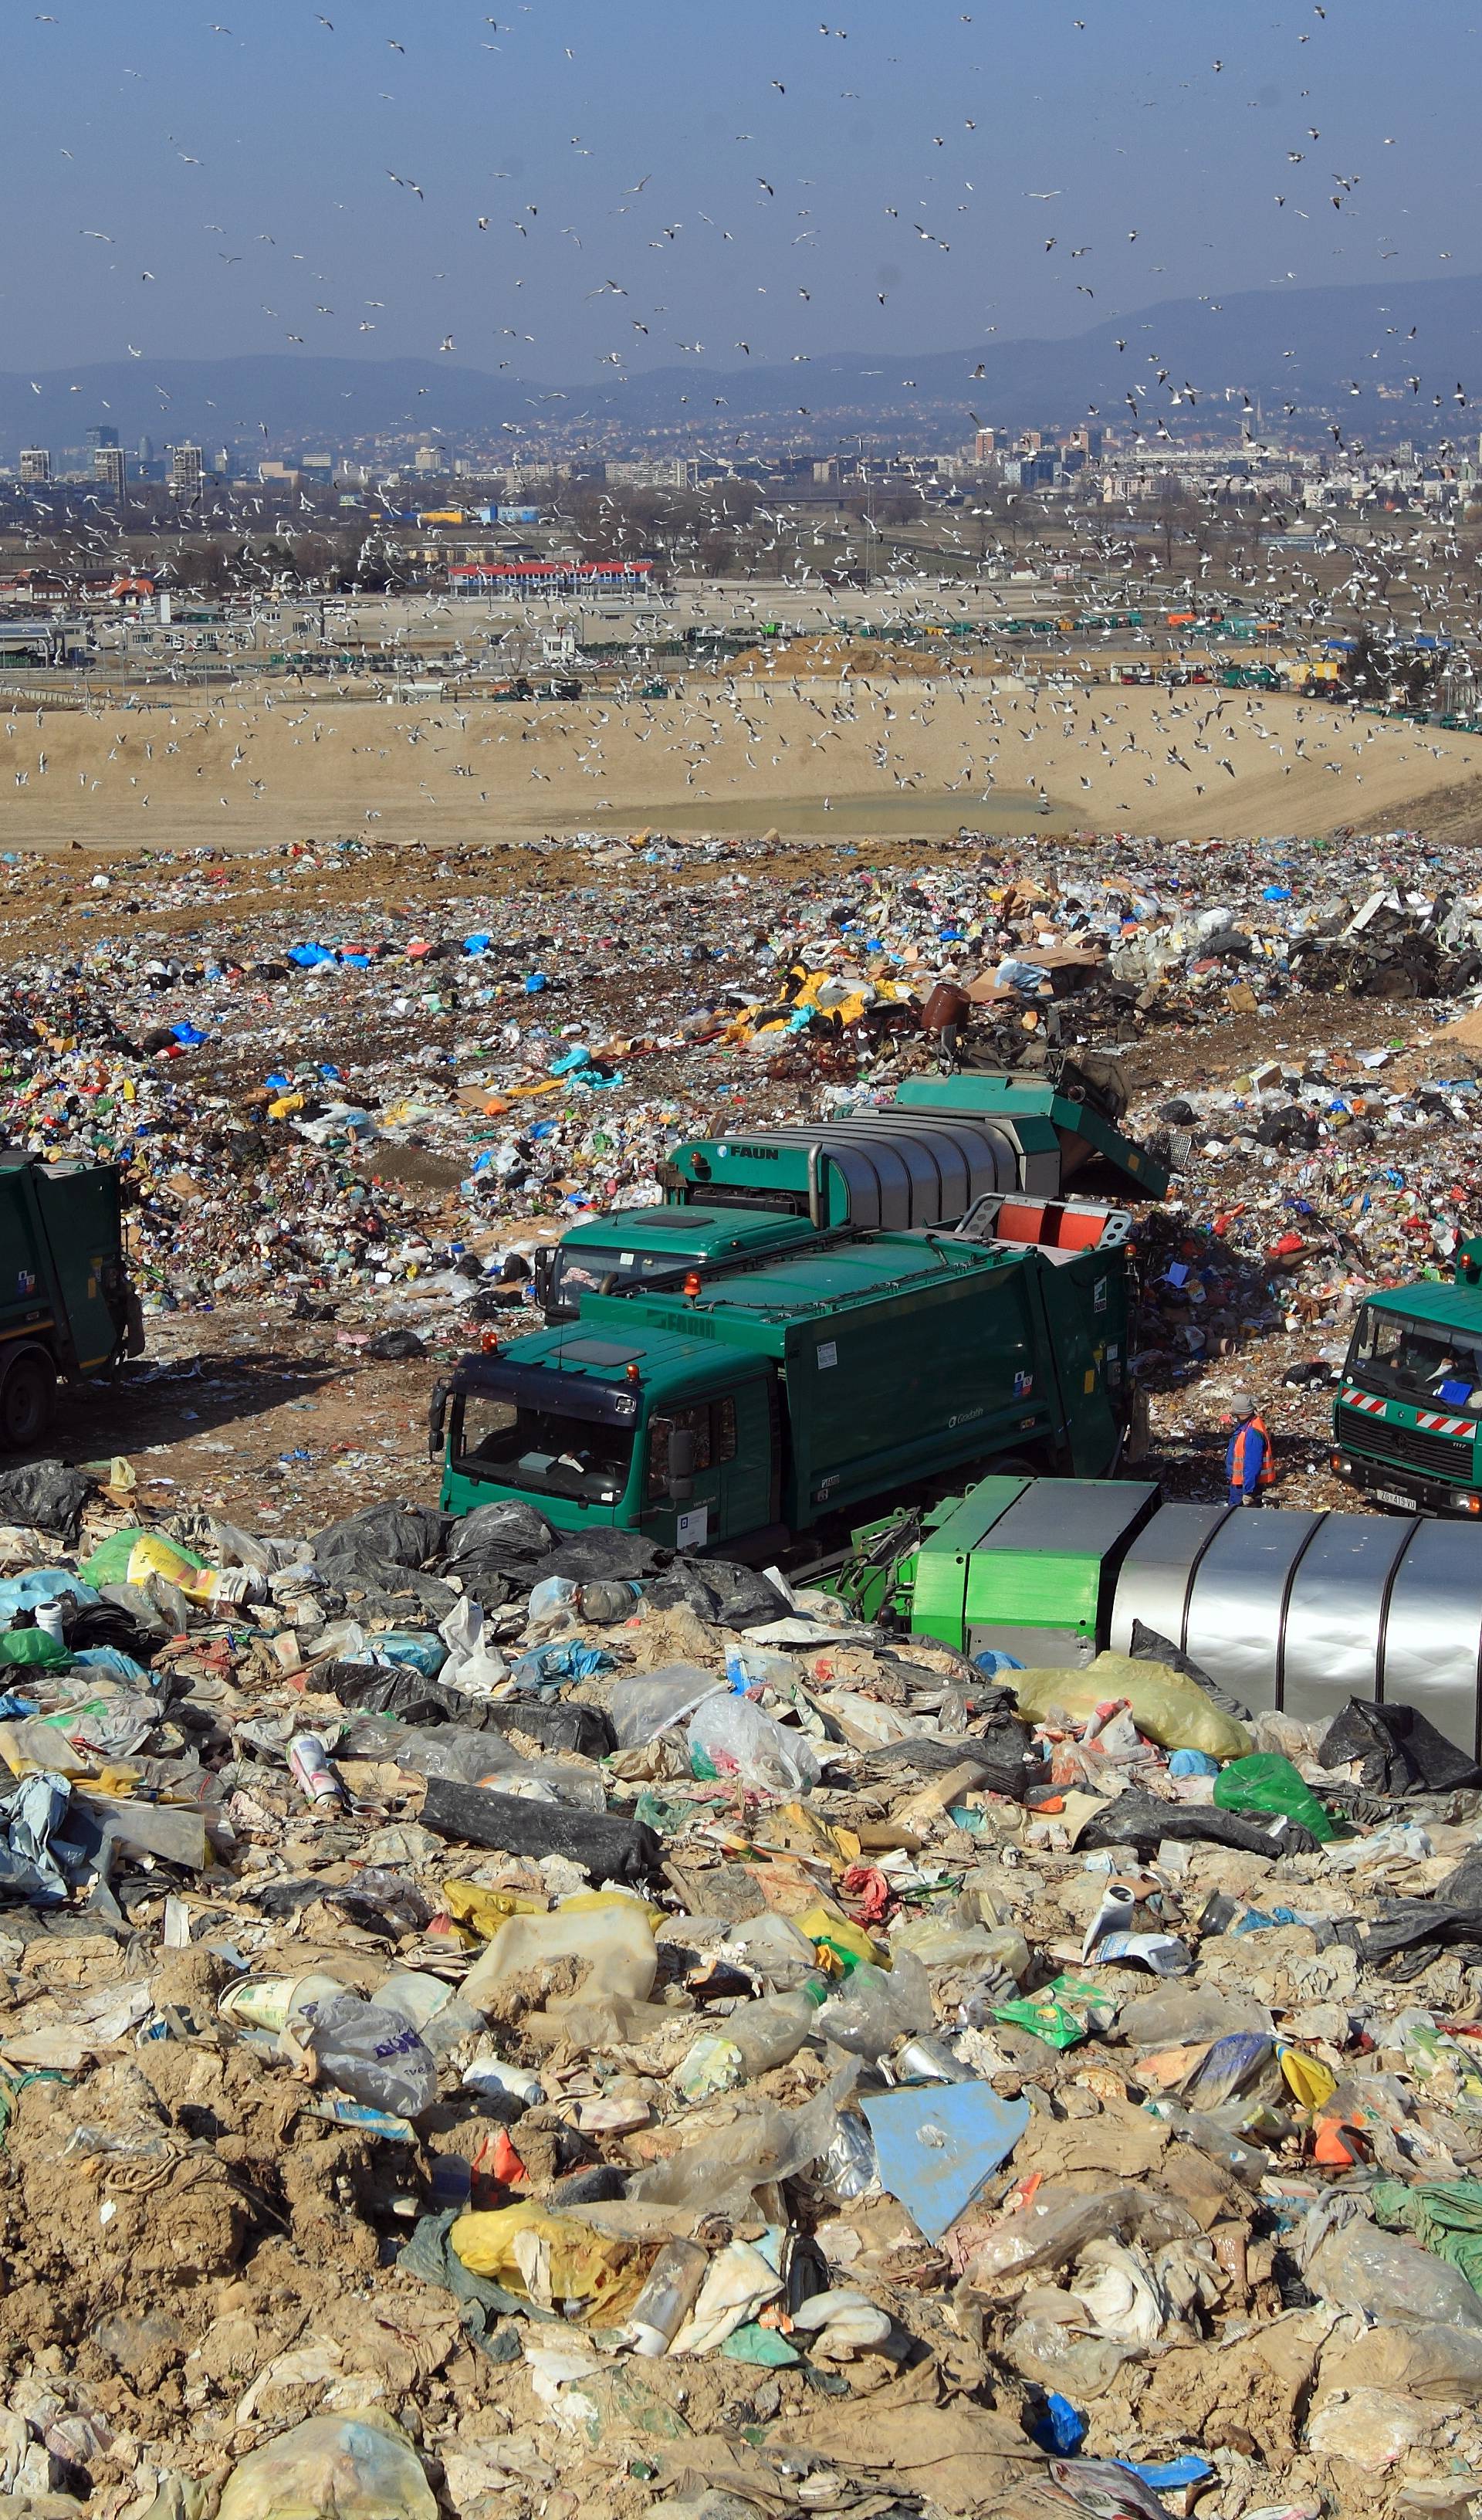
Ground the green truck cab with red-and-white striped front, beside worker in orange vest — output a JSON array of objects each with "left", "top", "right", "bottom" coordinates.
[{"left": 1333, "top": 1242, "right": 1482, "bottom": 1515}]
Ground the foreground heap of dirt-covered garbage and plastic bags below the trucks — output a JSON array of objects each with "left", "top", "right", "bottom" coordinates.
[{"left": 0, "top": 1462, "right": 1482, "bottom": 2520}]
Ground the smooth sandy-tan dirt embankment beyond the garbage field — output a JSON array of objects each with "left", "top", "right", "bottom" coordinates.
[{"left": 0, "top": 672, "right": 1482, "bottom": 849}]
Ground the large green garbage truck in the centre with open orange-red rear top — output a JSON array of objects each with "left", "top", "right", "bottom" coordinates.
[{"left": 428, "top": 1192, "right": 1139, "bottom": 1563}]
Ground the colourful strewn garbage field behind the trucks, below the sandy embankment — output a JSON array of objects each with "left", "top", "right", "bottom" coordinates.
[{"left": 0, "top": 834, "right": 1482, "bottom": 1360}]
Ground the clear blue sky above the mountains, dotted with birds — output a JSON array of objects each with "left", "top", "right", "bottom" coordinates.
[{"left": 0, "top": 0, "right": 1482, "bottom": 383}]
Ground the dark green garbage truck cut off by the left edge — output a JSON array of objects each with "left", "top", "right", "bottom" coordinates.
[{"left": 0, "top": 1147, "right": 144, "bottom": 1451}]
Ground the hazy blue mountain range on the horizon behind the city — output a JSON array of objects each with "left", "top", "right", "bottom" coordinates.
[{"left": 0, "top": 277, "right": 1482, "bottom": 456}]
